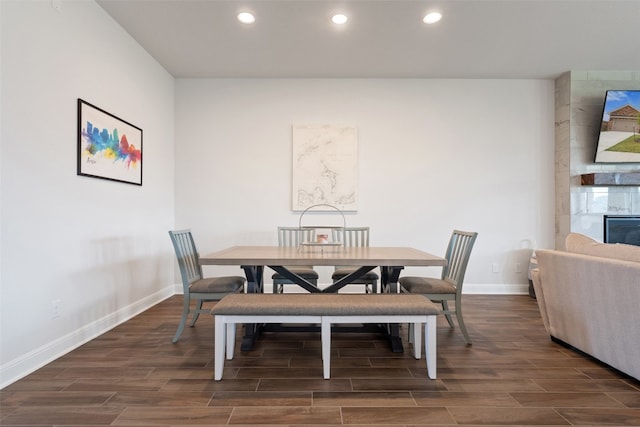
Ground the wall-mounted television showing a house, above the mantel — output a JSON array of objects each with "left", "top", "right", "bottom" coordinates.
[{"left": 595, "top": 90, "right": 640, "bottom": 163}]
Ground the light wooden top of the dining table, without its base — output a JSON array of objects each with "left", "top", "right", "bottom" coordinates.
[{"left": 200, "top": 245, "right": 447, "bottom": 267}]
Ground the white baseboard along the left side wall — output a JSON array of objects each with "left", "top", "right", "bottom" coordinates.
[{"left": 0, "top": 286, "right": 175, "bottom": 389}]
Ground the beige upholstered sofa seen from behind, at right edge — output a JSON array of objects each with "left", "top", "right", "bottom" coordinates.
[{"left": 531, "top": 233, "right": 640, "bottom": 380}]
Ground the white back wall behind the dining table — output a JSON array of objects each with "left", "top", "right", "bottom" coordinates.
[{"left": 176, "top": 79, "right": 554, "bottom": 292}]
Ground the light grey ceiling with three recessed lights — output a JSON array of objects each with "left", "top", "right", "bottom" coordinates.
[{"left": 97, "top": 0, "right": 640, "bottom": 79}]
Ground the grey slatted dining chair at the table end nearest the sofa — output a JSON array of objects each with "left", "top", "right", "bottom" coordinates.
[{"left": 398, "top": 230, "right": 478, "bottom": 345}]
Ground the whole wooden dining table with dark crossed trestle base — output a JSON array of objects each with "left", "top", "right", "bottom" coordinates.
[{"left": 199, "top": 245, "right": 447, "bottom": 352}]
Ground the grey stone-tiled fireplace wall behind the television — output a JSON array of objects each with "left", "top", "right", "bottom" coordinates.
[{"left": 555, "top": 71, "right": 640, "bottom": 249}]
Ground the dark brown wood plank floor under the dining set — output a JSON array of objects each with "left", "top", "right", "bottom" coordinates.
[{"left": 0, "top": 295, "right": 640, "bottom": 427}]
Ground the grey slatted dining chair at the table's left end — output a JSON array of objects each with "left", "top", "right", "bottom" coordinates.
[{"left": 169, "top": 230, "right": 245, "bottom": 344}]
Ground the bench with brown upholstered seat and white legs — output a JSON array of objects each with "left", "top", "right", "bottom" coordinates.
[{"left": 211, "top": 293, "right": 440, "bottom": 381}]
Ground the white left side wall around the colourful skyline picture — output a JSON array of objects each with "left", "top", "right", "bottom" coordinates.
[{"left": 0, "top": 0, "right": 174, "bottom": 387}]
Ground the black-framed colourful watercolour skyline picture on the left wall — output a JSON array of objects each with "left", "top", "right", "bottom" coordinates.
[{"left": 78, "top": 99, "right": 142, "bottom": 185}]
